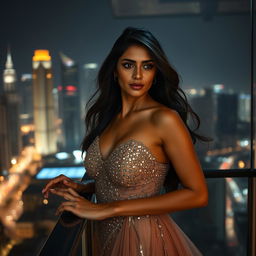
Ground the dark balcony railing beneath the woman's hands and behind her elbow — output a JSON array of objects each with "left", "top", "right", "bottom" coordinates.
[{"left": 38, "top": 169, "right": 256, "bottom": 256}]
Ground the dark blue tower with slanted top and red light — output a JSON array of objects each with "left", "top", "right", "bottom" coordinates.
[{"left": 58, "top": 53, "right": 82, "bottom": 152}]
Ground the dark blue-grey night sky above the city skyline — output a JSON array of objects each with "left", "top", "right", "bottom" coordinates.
[{"left": 0, "top": 0, "right": 250, "bottom": 92}]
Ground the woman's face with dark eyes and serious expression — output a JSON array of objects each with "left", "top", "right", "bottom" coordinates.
[{"left": 115, "top": 45, "right": 156, "bottom": 97}]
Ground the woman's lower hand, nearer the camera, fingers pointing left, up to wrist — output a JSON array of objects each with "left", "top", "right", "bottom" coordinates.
[{"left": 51, "top": 188, "right": 107, "bottom": 220}]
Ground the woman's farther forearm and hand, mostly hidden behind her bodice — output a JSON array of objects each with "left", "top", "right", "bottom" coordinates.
[{"left": 42, "top": 174, "right": 95, "bottom": 198}]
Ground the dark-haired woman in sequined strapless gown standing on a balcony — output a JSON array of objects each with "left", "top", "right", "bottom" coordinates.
[{"left": 43, "top": 28, "right": 208, "bottom": 256}]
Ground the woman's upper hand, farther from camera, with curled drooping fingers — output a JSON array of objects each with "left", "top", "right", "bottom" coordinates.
[{"left": 42, "top": 174, "right": 85, "bottom": 198}]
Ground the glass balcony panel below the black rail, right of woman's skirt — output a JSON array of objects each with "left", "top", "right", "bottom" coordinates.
[{"left": 172, "top": 178, "right": 248, "bottom": 256}]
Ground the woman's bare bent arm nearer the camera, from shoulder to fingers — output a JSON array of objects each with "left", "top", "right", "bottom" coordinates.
[{"left": 53, "top": 109, "right": 208, "bottom": 220}]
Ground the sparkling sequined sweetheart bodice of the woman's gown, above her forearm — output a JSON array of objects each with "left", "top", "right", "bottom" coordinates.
[{"left": 85, "top": 136, "right": 169, "bottom": 202}]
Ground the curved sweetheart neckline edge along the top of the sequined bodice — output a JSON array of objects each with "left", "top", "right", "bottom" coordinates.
[{"left": 96, "top": 135, "right": 169, "bottom": 165}]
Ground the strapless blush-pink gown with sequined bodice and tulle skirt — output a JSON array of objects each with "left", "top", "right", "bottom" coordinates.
[{"left": 85, "top": 136, "right": 202, "bottom": 256}]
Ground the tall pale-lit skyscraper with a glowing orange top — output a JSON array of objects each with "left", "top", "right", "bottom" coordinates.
[{"left": 32, "top": 50, "right": 57, "bottom": 155}]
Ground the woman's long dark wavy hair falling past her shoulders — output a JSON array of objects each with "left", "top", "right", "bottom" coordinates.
[{"left": 81, "top": 27, "right": 209, "bottom": 191}]
